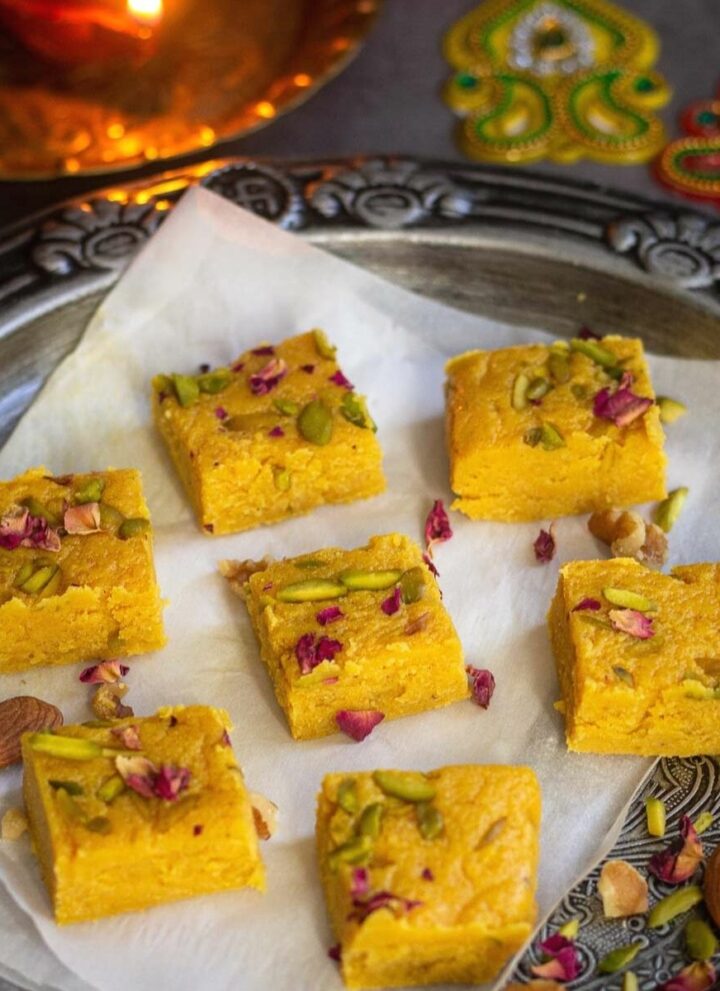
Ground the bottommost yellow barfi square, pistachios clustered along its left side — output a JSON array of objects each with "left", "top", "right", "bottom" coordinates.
[{"left": 317, "top": 765, "right": 540, "bottom": 988}]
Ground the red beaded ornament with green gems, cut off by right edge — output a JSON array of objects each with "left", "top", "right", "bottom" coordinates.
[{"left": 656, "top": 89, "right": 720, "bottom": 207}]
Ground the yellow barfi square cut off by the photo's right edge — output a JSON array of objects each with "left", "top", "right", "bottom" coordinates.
[{"left": 548, "top": 558, "right": 720, "bottom": 757}]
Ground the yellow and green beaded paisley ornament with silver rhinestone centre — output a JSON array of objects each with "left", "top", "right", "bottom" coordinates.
[{"left": 444, "top": 0, "right": 670, "bottom": 164}]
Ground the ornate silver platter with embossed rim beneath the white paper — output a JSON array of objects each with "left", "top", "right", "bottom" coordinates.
[{"left": 0, "top": 158, "right": 720, "bottom": 991}]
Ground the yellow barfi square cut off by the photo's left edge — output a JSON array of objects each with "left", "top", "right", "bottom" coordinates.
[{"left": 0, "top": 468, "right": 165, "bottom": 673}]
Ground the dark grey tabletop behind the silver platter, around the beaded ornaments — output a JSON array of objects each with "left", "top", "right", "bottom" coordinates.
[{"left": 0, "top": 0, "right": 720, "bottom": 224}]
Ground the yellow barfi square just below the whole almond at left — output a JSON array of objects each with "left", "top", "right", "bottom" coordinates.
[{"left": 22, "top": 705, "right": 265, "bottom": 923}]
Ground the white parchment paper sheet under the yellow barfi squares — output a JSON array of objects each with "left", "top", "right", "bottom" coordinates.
[{"left": 0, "top": 190, "right": 720, "bottom": 991}]
